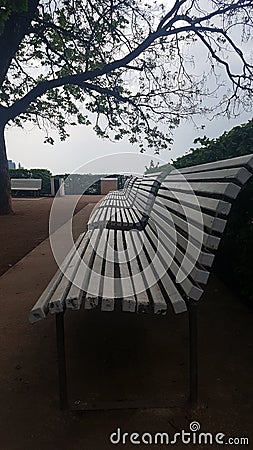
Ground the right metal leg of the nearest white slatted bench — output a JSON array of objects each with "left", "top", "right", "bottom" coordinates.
[{"left": 188, "top": 300, "right": 198, "bottom": 406}]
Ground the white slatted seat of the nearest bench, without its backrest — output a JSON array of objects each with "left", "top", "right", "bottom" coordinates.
[{"left": 30, "top": 229, "right": 186, "bottom": 322}]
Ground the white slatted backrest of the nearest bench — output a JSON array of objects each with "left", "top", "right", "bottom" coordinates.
[{"left": 145, "top": 155, "right": 253, "bottom": 306}]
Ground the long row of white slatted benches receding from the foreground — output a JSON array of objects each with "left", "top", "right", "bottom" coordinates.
[{"left": 29, "top": 155, "right": 253, "bottom": 409}]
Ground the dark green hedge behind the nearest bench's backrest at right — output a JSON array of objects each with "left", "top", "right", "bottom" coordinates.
[{"left": 165, "top": 120, "right": 253, "bottom": 307}]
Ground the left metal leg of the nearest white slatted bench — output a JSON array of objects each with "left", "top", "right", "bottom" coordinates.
[{"left": 55, "top": 312, "right": 69, "bottom": 409}]
